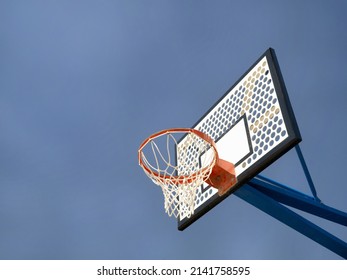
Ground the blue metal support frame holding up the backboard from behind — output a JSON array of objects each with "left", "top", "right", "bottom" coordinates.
[{"left": 234, "top": 145, "right": 347, "bottom": 259}]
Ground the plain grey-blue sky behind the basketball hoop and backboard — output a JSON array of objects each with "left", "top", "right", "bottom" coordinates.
[{"left": 0, "top": 0, "right": 347, "bottom": 259}]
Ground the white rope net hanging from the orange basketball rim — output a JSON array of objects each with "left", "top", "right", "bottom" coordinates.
[{"left": 139, "top": 131, "right": 217, "bottom": 218}]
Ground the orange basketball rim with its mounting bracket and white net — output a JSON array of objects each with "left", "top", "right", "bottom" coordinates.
[{"left": 138, "top": 128, "right": 237, "bottom": 218}]
